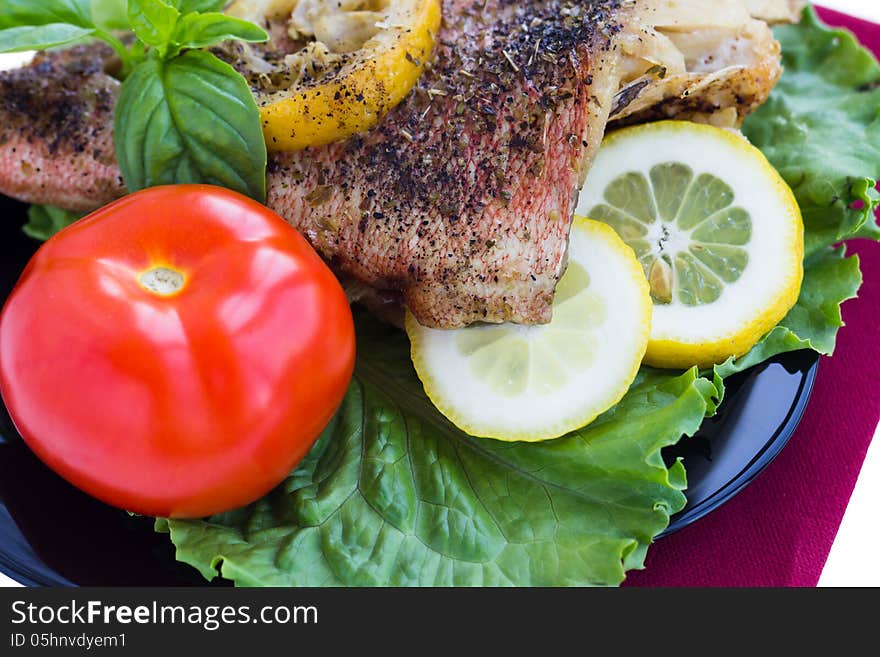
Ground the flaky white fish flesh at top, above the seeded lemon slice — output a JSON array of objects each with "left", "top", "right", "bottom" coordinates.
[{"left": 610, "top": 0, "right": 804, "bottom": 127}]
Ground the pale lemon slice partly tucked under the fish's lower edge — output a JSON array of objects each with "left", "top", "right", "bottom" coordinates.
[{"left": 406, "top": 218, "right": 651, "bottom": 442}]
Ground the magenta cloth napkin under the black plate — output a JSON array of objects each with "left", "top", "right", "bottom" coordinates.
[{"left": 627, "top": 9, "right": 880, "bottom": 587}]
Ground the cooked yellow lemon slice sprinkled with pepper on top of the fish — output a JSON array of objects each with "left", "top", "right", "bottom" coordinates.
[{"left": 227, "top": 0, "right": 442, "bottom": 150}]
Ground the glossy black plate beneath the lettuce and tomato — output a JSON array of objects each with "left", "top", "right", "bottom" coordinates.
[{"left": 0, "top": 197, "right": 818, "bottom": 586}]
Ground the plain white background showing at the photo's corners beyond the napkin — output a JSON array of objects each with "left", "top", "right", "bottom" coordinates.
[{"left": 0, "top": 0, "right": 880, "bottom": 586}]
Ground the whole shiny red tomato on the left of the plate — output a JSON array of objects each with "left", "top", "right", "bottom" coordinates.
[{"left": 0, "top": 185, "right": 355, "bottom": 518}]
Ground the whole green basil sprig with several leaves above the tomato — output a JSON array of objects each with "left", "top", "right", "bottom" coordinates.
[{"left": 0, "top": 0, "right": 268, "bottom": 201}]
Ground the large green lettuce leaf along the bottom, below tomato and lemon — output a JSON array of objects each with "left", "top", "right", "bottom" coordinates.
[{"left": 159, "top": 317, "right": 718, "bottom": 586}]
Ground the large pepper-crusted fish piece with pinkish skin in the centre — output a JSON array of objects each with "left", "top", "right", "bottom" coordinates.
[{"left": 269, "top": 0, "right": 622, "bottom": 328}]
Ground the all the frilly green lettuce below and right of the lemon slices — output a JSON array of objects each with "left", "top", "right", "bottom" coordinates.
[{"left": 156, "top": 10, "right": 880, "bottom": 586}]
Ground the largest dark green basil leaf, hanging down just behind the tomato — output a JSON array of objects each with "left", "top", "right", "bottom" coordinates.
[{"left": 115, "top": 50, "right": 267, "bottom": 202}]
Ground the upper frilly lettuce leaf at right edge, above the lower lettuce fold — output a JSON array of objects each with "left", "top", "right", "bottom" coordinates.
[{"left": 743, "top": 9, "right": 880, "bottom": 255}]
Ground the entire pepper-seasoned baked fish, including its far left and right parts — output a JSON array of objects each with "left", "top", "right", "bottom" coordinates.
[{"left": 0, "top": 0, "right": 792, "bottom": 328}]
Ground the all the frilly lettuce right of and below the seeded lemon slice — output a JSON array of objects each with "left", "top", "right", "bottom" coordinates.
[{"left": 716, "top": 7, "right": 880, "bottom": 377}]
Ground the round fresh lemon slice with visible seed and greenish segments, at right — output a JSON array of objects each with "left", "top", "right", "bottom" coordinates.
[{"left": 578, "top": 121, "right": 804, "bottom": 368}]
